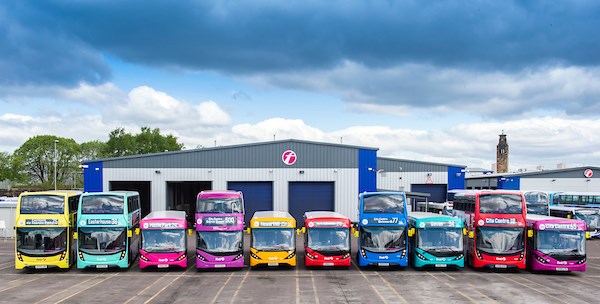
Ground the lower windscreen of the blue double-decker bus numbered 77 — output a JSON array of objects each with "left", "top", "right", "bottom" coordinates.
[{"left": 360, "top": 226, "right": 406, "bottom": 253}]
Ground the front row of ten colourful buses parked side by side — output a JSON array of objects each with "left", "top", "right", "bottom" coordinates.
[{"left": 15, "top": 191, "right": 586, "bottom": 271}]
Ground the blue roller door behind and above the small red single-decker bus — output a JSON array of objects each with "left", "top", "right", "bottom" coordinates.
[{"left": 288, "top": 182, "right": 335, "bottom": 227}]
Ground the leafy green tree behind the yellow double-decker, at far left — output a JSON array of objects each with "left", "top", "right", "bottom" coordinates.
[{"left": 13, "top": 135, "right": 81, "bottom": 188}]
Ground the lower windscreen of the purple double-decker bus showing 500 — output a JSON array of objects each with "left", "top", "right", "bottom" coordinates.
[{"left": 197, "top": 231, "right": 243, "bottom": 254}]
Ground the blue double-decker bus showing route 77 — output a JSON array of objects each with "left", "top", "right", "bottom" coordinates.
[{"left": 356, "top": 192, "right": 408, "bottom": 267}]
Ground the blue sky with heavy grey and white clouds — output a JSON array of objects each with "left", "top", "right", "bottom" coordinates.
[{"left": 0, "top": 0, "right": 600, "bottom": 171}]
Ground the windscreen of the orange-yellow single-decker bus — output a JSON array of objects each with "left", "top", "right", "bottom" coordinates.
[{"left": 252, "top": 228, "right": 296, "bottom": 251}]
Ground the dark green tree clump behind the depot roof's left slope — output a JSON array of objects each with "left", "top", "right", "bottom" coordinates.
[{"left": 105, "top": 127, "right": 183, "bottom": 157}]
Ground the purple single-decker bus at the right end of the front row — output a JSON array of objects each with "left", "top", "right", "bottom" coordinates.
[{"left": 527, "top": 214, "right": 587, "bottom": 271}]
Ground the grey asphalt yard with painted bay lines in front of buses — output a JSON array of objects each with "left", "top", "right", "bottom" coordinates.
[{"left": 0, "top": 238, "right": 600, "bottom": 304}]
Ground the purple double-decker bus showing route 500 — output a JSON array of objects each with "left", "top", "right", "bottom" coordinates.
[{"left": 196, "top": 190, "right": 244, "bottom": 268}]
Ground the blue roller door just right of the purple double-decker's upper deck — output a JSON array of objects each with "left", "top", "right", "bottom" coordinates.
[{"left": 227, "top": 182, "right": 273, "bottom": 226}]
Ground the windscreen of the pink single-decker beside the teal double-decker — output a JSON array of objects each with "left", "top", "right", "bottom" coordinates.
[{"left": 142, "top": 229, "right": 186, "bottom": 252}]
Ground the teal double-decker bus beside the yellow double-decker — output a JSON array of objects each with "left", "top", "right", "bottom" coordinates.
[{"left": 77, "top": 191, "right": 141, "bottom": 269}]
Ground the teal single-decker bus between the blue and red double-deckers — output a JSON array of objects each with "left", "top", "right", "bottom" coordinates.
[{"left": 408, "top": 212, "right": 466, "bottom": 268}]
